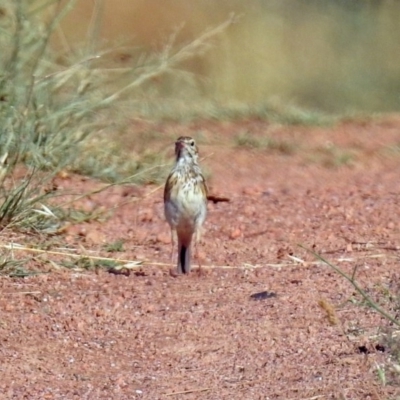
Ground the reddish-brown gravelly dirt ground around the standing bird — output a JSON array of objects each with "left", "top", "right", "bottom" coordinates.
[{"left": 0, "top": 116, "right": 400, "bottom": 400}]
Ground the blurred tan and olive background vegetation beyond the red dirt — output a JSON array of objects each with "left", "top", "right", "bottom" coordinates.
[{"left": 55, "top": 0, "right": 400, "bottom": 114}]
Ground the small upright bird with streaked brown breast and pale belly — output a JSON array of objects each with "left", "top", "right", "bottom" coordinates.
[{"left": 164, "top": 136, "right": 208, "bottom": 274}]
